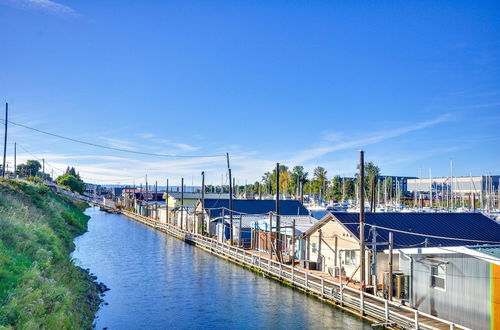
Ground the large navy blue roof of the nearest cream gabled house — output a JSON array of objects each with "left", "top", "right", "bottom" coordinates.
[{"left": 306, "top": 212, "right": 500, "bottom": 250}]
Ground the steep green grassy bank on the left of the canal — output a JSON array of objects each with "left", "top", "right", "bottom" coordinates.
[{"left": 0, "top": 180, "right": 99, "bottom": 329}]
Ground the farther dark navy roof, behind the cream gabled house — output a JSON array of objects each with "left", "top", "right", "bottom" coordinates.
[{"left": 205, "top": 199, "right": 309, "bottom": 217}]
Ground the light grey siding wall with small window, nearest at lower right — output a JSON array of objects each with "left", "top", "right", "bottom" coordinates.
[{"left": 400, "top": 254, "right": 491, "bottom": 330}]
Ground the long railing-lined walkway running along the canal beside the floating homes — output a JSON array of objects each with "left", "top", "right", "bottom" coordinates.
[{"left": 122, "top": 211, "right": 468, "bottom": 329}]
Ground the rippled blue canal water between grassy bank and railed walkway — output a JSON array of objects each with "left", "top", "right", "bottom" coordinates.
[{"left": 73, "top": 208, "right": 371, "bottom": 329}]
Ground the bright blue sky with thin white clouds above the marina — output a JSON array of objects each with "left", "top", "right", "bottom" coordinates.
[{"left": 0, "top": 0, "right": 500, "bottom": 184}]
